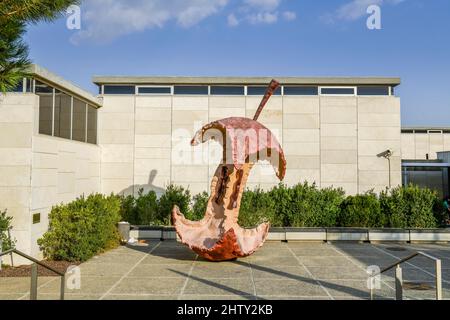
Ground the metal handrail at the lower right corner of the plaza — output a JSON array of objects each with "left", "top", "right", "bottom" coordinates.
[{"left": 370, "top": 251, "right": 442, "bottom": 300}]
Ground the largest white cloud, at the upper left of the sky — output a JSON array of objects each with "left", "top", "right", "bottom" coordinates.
[{"left": 71, "top": 0, "right": 229, "bottom": 43}]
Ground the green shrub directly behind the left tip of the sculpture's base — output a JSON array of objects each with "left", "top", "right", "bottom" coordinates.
[{"left": 157, "top": 184, "right": 191, "bottom": 225}]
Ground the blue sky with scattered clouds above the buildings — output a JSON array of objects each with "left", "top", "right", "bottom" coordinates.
[{"left": 26, "top": 0, "right": 450, "bottom": 126}]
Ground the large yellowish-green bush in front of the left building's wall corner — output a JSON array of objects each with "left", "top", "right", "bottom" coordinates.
[{"left": 38, "top": 194, "right": 120, "bottom": 262}]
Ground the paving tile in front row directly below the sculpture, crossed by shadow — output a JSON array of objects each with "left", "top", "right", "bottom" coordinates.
[{"left": 183, "top": 276, "right": 254, "bottom": 295}]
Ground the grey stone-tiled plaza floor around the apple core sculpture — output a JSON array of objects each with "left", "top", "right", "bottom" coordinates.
[{"left": 0, "top": 240, "right": 450, "bottom": 300}]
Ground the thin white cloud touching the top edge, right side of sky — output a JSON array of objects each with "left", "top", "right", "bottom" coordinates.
[{"left": 322, "top": 0, "right": 406, "bottom": 23}]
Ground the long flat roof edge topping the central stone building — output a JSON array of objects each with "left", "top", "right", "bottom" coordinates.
[{"left": 92, "top": 76, "right": 401, "bottom": 87}]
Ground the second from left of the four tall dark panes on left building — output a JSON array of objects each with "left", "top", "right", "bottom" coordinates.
[{"left": 53, "top": 90, "right": 72, "bottom": 139}]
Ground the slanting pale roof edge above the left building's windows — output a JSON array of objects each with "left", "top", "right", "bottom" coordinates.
[{"left": 28, "top": 64, "right": 102, "bottom": 108}]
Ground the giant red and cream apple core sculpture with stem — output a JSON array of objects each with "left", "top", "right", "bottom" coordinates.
[{"left": 172, "top": 80, "right": 286, "bottom": 261}]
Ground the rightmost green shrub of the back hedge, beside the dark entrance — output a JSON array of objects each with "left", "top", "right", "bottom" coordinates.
[{"left": 380, "top": 185, "right": 442, "bottom": 228}]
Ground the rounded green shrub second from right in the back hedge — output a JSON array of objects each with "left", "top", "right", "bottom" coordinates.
[{"left": 337, "top": 191, "right": 385, "bottom": 228}]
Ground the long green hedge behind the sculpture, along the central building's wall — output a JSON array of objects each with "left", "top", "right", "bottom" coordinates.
[{"left": 121, "top": 183, "right": 444, "bottom": 228}]
